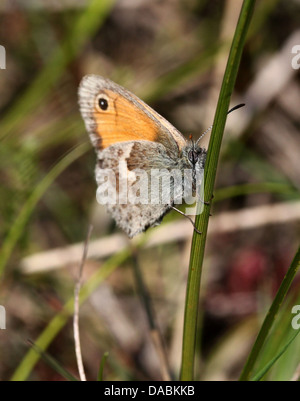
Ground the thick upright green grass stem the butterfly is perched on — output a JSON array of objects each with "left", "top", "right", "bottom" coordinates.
[{"left": 180, "top": 0, "right": 255, "bottom": 380}]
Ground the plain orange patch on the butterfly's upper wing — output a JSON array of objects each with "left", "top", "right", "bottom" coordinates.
[{"left": 93, "top": 89, "right": 159, "bottom": 149}]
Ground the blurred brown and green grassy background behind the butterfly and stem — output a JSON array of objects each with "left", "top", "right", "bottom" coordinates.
[{"left": 0, "top": 0, "right": 300, "bottom": 380}]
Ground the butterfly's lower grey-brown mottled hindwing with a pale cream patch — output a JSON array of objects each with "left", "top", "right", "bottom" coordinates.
[{"left": 96, "top": 141, "right": 181, "bottom": 238}]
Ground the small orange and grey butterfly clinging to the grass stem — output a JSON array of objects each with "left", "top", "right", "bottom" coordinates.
[{"left": 79, "top": 75, "right": 206, "bottom": 238}]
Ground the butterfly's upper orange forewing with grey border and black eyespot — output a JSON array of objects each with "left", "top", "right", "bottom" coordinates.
[{"left": 79, "top": 75, "right": 186, "bottom": 154}]
